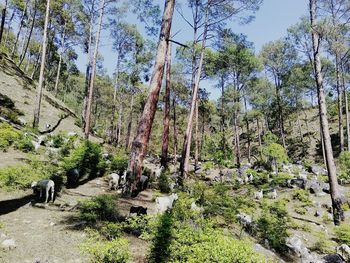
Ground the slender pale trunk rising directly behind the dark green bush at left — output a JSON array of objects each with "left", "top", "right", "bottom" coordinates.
[{"left": 84, "top": 0, "right": 105, "bottom": 139}]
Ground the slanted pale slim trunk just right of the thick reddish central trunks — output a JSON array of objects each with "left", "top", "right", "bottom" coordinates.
[{"left": 179, "top": 7, "right": 209, "bottom": 182}]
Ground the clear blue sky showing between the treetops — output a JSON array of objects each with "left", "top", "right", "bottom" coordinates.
[{"left": 77, "top": 0, "right": 308, "bottom": 99}]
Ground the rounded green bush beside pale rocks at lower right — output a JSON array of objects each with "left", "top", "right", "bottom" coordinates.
[{"left": 257, "top": 201, "right": 290, "bottom": 252}]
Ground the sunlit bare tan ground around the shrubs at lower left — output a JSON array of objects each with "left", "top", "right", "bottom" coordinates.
[{"left": 0, "top": 178, "right": 153, "bottom": 263}]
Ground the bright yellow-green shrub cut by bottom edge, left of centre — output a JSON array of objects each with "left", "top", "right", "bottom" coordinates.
[{"left": 81, "top": 230, "right": 131, "bottom": 263}]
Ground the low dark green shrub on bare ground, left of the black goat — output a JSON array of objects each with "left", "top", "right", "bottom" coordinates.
[{"left": 79, "top": 195, "right": 118, "bottom": 224}]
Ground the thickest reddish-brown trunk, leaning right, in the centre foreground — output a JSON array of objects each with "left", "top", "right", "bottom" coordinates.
[{"left": 124, "top": 0, "right": 175, "bottom": 195}]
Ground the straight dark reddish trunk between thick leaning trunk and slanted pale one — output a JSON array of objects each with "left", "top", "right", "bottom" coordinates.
[{"left": 160, "top": 42, "right": 171, "bottom": 167}]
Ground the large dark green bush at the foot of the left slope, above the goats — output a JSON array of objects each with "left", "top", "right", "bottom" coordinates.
[{"left": 62, "top": 140, "right": 104, "bottom": 177}]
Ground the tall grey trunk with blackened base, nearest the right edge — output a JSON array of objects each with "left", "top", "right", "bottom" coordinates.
[{"left": 309, "top": 0, "right": 345, "bottom": 225}]
